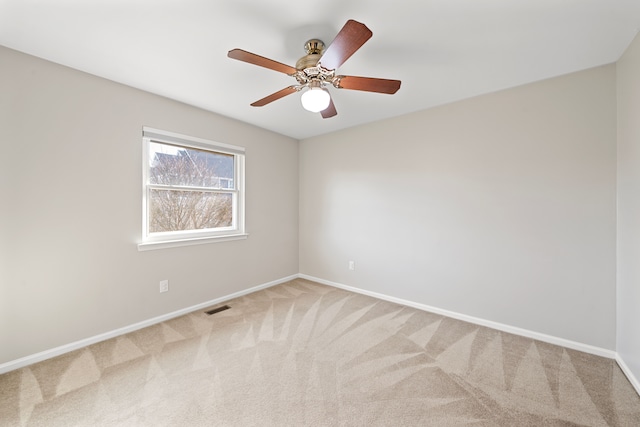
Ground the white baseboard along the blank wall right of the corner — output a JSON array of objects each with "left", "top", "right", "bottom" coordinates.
[{"left": 298, "top": 274, "right": 617, "bottom": 359}]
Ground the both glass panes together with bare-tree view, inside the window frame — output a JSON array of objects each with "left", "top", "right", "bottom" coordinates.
[{"left": 147, "top": 142, "right": 235, "bottom": 233}]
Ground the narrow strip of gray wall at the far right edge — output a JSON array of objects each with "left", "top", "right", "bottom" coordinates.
[{"left": 617, "top": 36, "right": 640, "bottom": 388}]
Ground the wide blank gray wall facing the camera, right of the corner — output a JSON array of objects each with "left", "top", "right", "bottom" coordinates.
[{"left": 300, "top": 65, "right": 616, "bottom": 350}]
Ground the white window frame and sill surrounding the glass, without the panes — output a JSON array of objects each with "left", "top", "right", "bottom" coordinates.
[{"left": 138, "top": 126, "right": 248, "bottom": 251}]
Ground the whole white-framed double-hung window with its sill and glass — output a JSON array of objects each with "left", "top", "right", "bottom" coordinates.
[{"left": 138, "top": 127, "right": 246, "bottom": 250}]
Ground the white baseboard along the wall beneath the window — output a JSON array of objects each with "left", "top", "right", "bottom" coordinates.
[{"left": 0, "top": 274, "right": 299, "bottom": 374}]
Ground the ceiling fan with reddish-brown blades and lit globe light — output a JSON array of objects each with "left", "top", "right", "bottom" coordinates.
[{"left": 227, "top": 19, "right": 401, "bottom": 119}]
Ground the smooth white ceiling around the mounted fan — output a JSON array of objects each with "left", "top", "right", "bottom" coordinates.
[{"left": 0, "top": 0, "right": 640, "bottom": 139}]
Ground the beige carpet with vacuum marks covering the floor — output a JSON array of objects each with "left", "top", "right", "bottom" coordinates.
[{"left": 0, "top": 280, "right": 640, "bottom": 427}]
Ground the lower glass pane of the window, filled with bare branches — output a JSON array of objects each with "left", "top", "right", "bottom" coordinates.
[{"left": 149, "top": 189, "right": 233, "bottom": 233}]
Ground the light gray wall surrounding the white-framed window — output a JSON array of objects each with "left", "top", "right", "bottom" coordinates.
[{"left": 0, "top": 47, "right": 298, "bottom": 363}]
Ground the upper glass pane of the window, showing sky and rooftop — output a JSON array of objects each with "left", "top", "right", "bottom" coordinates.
[{"left": 149, "top": 142, "right": 234, "bottom": 189}]
